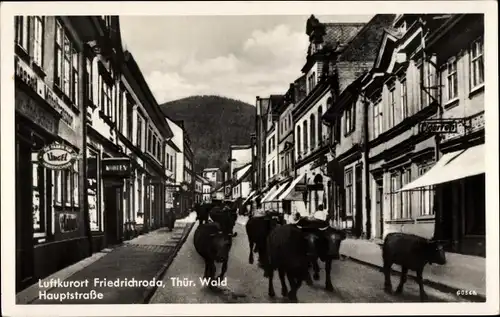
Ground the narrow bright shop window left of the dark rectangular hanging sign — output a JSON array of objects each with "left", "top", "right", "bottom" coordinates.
[{"left": 87, "top": 149, "right": 102, "bottom": 231}]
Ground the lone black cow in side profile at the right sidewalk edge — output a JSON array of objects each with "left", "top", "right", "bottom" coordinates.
[{"left": 382, "top": 232, "right": 446, "bottom": 301}]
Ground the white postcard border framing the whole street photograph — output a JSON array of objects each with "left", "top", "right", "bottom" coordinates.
[{"left": 0, "top": 1, "right": 499, "bottom": 316}]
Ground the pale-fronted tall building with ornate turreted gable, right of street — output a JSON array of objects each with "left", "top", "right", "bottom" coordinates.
[{"left": 284, "top": 16, "right": 364, "bottom": 215}]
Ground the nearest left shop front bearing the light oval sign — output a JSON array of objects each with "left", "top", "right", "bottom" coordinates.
[{"left": 15, "top": 57, "right": 89, "bottom": 292}]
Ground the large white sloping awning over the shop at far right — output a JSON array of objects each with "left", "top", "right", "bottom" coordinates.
[{"left": 397, "top": 144, "right": 485, "bottom": 192}]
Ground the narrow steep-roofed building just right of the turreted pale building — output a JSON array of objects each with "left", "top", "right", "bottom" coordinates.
[{"left": 323, "top": 14, "right": 395, "bottom": 237}]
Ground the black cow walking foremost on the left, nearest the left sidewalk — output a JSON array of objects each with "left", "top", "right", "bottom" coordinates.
[{"left": 193, "top": 222, "right": 232, "bottom": 279}]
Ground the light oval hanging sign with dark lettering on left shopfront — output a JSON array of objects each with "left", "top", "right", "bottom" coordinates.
[{"left": 38, "top": 143, "right": 77, "bottom": 170}]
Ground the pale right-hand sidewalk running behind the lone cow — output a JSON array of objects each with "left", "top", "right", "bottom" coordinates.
[{"left": 340, "top": 238, "right": 486, "bottom": 300}]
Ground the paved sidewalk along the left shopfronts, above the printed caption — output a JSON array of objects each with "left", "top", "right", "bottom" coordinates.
[{"left": 16, "top": 219, "right": 194, "bottom": 304}]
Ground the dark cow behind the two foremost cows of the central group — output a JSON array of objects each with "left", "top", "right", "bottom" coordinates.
[{"left": 245, "top": 211, "right": 285, "bottom": 267}]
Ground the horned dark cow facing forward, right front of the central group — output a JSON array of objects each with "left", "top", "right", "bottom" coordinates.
[{"left": 295, "top": 218, "right": 346, "bottom": 292}]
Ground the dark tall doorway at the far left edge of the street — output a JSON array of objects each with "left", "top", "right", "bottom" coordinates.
[{"left": 15, "top": 135, "right": 35, "bottom": 292}]
